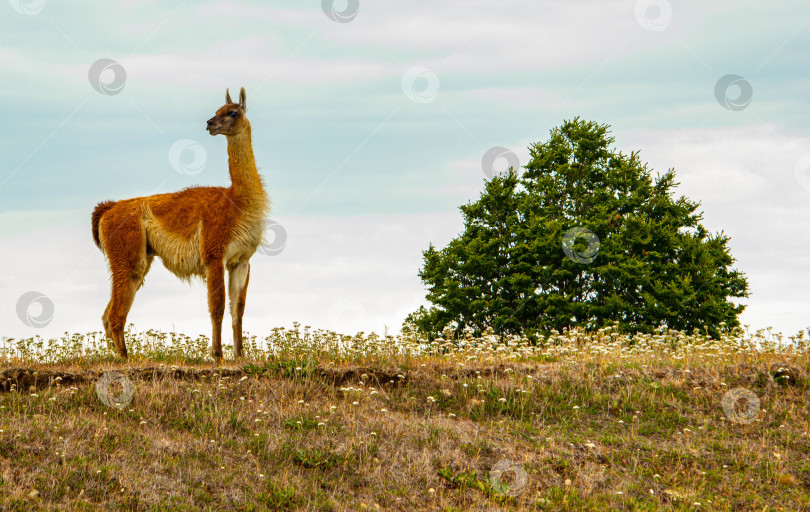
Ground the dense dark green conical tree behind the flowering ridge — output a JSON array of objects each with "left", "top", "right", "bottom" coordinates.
[{"left": 406, "top": 118, "right": 748, "bottom": 337}]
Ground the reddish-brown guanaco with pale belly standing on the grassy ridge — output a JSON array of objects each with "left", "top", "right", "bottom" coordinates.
[{"left": 92, "top": 88, "right": 270, "bottom": 360}]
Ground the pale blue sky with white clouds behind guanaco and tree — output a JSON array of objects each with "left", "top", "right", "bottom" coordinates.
[{"left": 0, "top": 0, "right": 810, "bottom": 344}]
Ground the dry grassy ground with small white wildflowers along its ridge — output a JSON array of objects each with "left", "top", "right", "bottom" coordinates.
[{"left": 0, "top": 326, "right": 810, "bottom": 511}]
